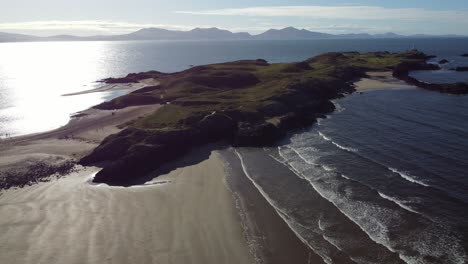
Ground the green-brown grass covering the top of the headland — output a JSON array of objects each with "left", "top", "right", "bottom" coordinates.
[{"left": 123, "top": 53, "right": 424, "bottom": 129}]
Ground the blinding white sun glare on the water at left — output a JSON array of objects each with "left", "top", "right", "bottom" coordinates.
[{"left": 0, "top": 42, "right": 120, "bottom": 137}]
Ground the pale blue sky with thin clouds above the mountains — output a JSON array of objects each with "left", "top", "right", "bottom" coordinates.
[{"left": 0, "top": 0, "right": 468, "bottom": 36}]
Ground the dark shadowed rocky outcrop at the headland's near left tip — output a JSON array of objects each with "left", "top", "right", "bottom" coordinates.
[{"left": 85, "top": 129, "right": 200, "bottom": 185}]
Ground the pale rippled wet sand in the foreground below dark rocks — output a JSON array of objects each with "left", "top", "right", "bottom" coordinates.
[{"left": 0, "top": 153, "right": 253, "bottom": 264}]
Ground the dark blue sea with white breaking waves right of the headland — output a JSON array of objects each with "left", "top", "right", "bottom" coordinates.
[{"left": 232, "top": 89, "right": 468, "bottom": 263}]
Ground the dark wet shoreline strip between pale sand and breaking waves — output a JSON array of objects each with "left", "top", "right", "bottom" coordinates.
[{"left": 222, "top": 149, "right": 323, "bottom": 264}]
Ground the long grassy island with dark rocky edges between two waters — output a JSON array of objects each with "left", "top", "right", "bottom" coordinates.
[{"left": 79, "top": 50, "right": 468, "bottom": 186}]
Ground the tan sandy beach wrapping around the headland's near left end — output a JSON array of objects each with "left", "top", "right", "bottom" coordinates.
[{"left": 0, "top": 78, "right": 318, "bottom": 264}]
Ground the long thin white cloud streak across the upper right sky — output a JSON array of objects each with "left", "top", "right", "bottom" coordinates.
[{"left": 176, "top": 6, "right": 468, "bottom": 22}]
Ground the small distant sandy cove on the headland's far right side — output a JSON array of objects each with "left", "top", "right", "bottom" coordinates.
[{"left": 354, "top": 71, "right": 414, "bottom": 91}]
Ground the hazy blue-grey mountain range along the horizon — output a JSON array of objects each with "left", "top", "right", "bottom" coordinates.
[{"left": 0, "top": 27, "right": 461, "bottom": 42}]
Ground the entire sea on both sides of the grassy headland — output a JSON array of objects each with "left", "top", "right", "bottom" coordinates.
[{"left": 0, "top": 39, "right": 468, "bottom": 263}]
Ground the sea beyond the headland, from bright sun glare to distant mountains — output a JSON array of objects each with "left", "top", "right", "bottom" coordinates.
[{"left": 0, "top": 38, "right": 468, "bottom": 138}]
